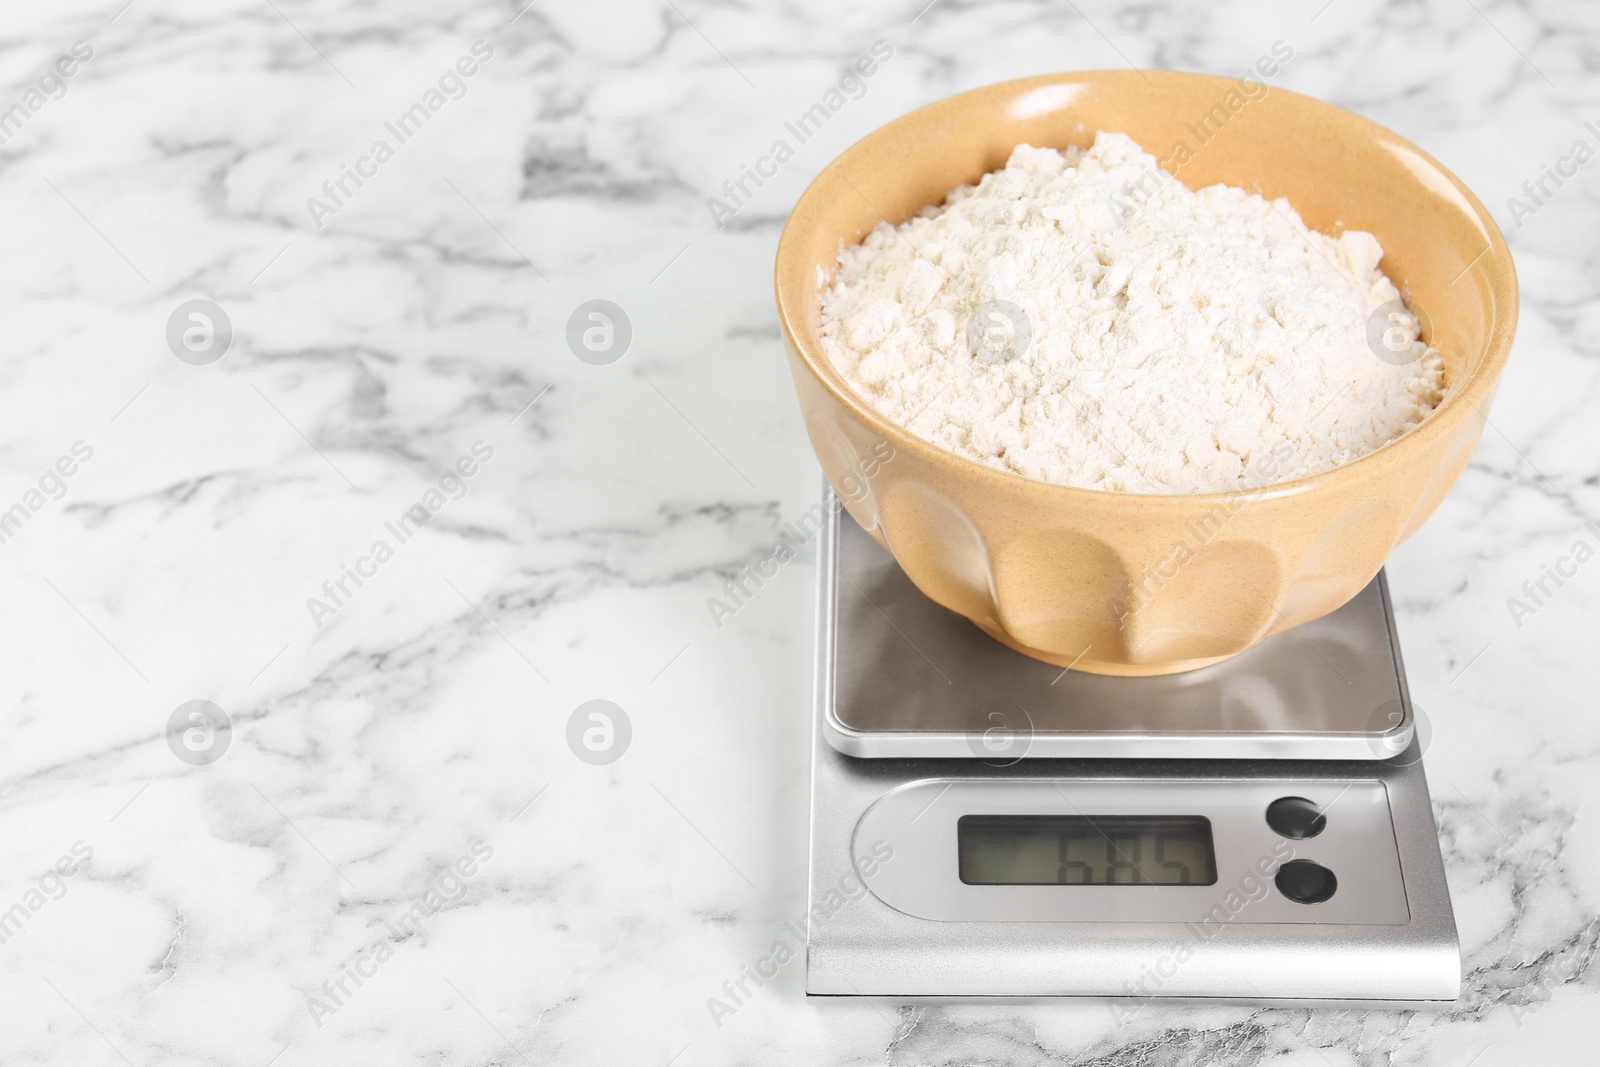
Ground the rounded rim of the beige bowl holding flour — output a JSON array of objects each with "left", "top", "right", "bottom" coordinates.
[{"left": 773, "top": 69, "right": 1520, "bottom": 506}]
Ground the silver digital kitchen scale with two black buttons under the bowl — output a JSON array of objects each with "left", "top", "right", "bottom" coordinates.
[{"left": 806, "top": 493, "right": 1461, "bottom": 1011}]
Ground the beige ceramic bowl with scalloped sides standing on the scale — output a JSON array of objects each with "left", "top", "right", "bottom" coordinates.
[{"left": 776, "top": 70, "right": 1517, "bottom": 675}]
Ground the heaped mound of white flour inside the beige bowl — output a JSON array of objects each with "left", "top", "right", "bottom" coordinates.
[{"left": 821, "top": 133, "right": 1443, "bottom": 493}]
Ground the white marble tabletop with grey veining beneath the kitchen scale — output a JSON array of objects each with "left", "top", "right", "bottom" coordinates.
[{"left": 0, "top": 0, "right": 1600, "bottom": 1067}]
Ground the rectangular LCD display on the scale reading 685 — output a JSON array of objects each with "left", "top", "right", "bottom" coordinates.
[{"left": 955, "top": 816, "right": 1216, "bottom": 886}]
